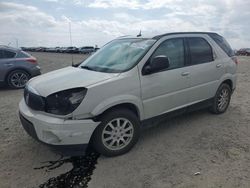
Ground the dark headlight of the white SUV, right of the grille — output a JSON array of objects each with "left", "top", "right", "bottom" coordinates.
[{"left": 45, "top": 88, "right": 87, "bottom": 115}]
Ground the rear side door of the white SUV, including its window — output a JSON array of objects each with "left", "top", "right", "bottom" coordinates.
[{"left": 185, "top": 36, "right": 224, "bottom": 104}]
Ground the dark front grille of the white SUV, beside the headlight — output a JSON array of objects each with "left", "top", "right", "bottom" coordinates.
[{"left": 24, "top": 88, "right": 45, "bottom": 111}]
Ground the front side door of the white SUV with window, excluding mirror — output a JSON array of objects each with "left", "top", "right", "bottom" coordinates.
[{"left": 140, "top": 38, "right": 188, "bottom": 119}]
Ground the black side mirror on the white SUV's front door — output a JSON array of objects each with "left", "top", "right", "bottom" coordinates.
[{"left": 142, "top": 55, "right": 169, "bottom": 75}]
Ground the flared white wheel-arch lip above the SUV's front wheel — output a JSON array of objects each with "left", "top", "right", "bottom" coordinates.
[{"left": 91, "top": 95, "right": 144, "bottom": 120}]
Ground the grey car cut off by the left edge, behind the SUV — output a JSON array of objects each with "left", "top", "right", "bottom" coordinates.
[{"left": 0, "top": 46, "right": 41, "bottom": 89}]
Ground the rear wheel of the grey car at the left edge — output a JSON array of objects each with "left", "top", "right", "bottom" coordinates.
[{"left": 7, "top": 70, "right": 30, "bottom": 89}]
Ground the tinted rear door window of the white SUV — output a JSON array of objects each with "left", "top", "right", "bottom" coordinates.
[{"left": 187, "top": 37, "right": 213, "bottom": 65}]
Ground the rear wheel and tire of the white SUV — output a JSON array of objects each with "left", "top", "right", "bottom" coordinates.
[{"left": 210, "top": 83, "right": 232, "bottom": 114}]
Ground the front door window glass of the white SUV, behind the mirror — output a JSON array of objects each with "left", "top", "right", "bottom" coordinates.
[{"left": 151, "top": 38, "right": 185, "bottom": 69}]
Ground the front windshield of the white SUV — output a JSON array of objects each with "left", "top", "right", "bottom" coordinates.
[{"left": 80, "top": 39, "right": 155, "bottom": 73}]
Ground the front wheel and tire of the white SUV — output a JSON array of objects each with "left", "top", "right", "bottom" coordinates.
[{"left": 91, "top": 109, "right": 140, "bottom": 157}]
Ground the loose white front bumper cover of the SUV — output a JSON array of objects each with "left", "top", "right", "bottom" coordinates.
[{"left": 19, "top": 99, "right": 100, "bottom": 146}]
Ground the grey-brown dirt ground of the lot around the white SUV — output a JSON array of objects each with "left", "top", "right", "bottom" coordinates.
[{"left": 0, "top": 53, "right": 250, "bottom": 188}]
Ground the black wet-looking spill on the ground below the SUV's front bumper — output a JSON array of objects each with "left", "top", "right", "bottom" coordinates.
[{"left": 34, "top": 149, "right": 99, "bottom": 188}]
